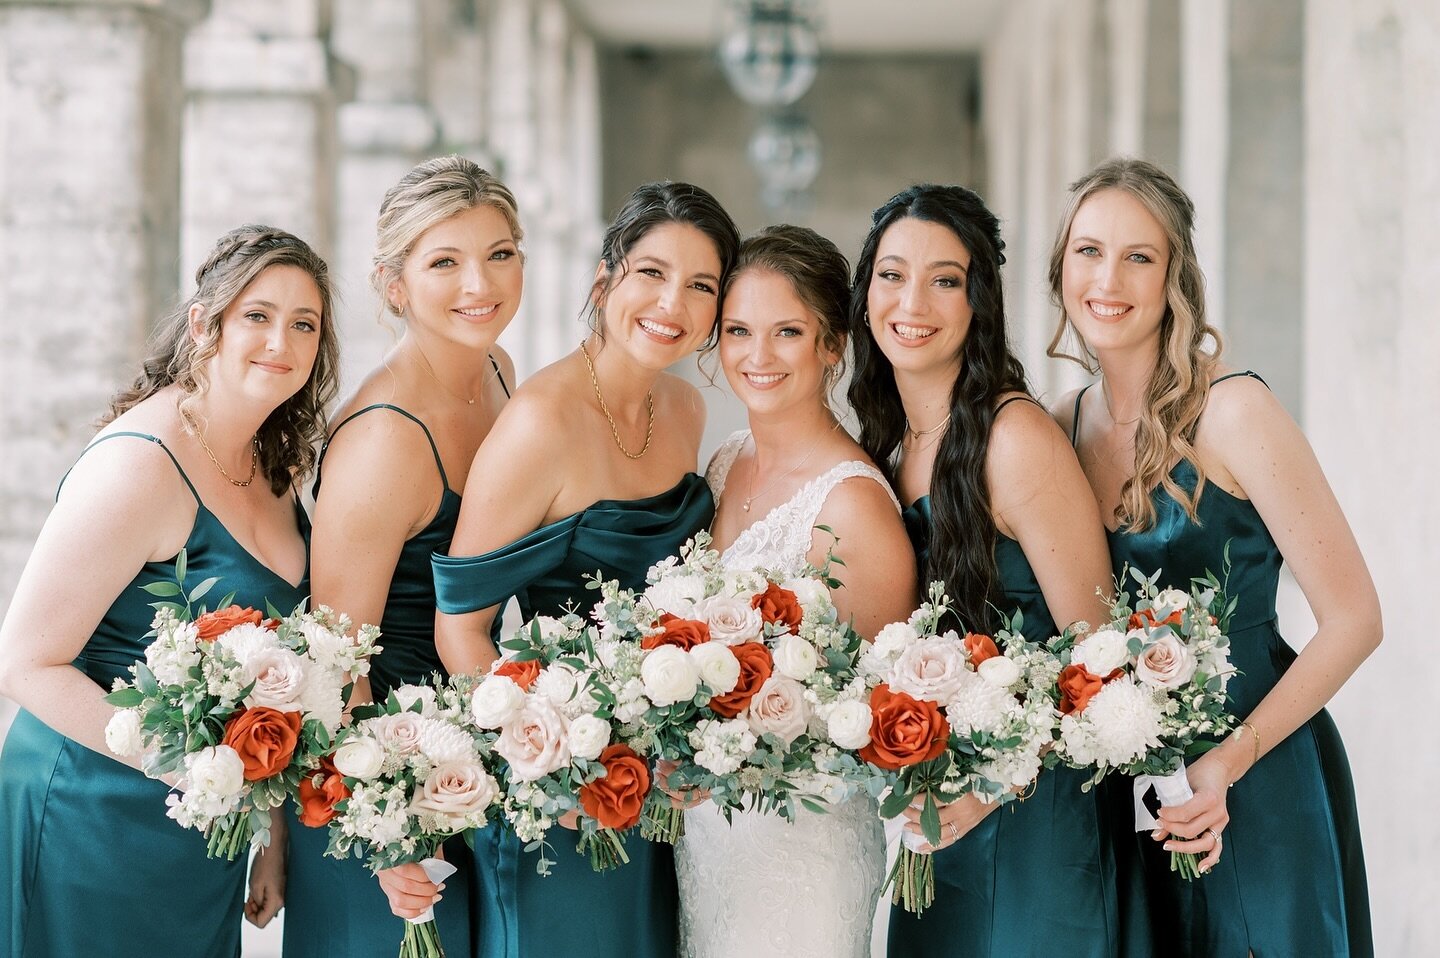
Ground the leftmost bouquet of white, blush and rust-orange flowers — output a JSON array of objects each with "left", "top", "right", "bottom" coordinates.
[{"left": 105, "top": 550, "right": 380, "bottom": 860}]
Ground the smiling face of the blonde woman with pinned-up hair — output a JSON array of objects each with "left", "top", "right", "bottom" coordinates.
[{"left": 387, "top": 206, "right": 524, "bottom": 349}]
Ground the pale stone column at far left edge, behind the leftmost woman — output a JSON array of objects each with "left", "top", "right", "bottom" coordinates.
[{"left": 0, "top": 0, "right": 204, "bottom": 614}]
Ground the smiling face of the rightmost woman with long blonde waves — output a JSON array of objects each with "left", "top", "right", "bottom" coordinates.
[{"left": 1061, "top": 189, "right": 1169, "bottom": 354}]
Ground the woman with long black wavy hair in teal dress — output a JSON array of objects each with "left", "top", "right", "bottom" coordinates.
[{"left": 850, "top": 186, "right": 1122, "bottom": 958}]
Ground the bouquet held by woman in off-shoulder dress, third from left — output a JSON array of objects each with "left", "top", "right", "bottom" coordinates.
[{"left": 469, "top": 614, "right": 651, "bottom": 874}]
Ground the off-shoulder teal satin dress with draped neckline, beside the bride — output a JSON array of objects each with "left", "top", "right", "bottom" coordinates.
[{"left": 433, "top": 473, "right": 714, "bottom": 958}]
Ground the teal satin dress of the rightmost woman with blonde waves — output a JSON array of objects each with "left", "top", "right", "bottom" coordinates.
[{"left": 1071, "top": 372, "right": 1374, "bottom": 958}]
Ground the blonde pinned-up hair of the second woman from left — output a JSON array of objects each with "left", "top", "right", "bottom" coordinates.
[{"left": 370, "top": 154, "right": 524, "bottom": 315}]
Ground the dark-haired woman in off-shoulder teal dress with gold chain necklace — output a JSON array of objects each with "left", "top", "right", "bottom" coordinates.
[{"left": 420, "top": 183, "right": 739, "bottom": 958}]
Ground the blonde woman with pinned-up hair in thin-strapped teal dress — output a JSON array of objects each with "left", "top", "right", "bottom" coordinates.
[{"left": 284, "top": 156, "right": 523, "bottom": 958}]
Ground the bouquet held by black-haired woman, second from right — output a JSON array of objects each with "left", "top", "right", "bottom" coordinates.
[{"left": 860, "top": 582, "right": 1060, "bottom": 913}]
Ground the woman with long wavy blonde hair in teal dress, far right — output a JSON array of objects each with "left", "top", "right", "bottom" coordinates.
[{"left": 1050, "top": 158, "right": 1381, "bottom": 958}]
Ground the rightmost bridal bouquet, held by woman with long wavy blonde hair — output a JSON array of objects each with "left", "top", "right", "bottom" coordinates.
[{"left": 1051, "top": 556, "right": 1234, "bottom": 880}]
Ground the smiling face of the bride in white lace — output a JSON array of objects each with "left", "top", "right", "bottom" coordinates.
[{"left": 720, "top": 268, "right": 840, "bottom": 415}]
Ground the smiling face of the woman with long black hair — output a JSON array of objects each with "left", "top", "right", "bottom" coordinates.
[{"left": 865, "top": 216, "right": 975, "bottom": 373}]
